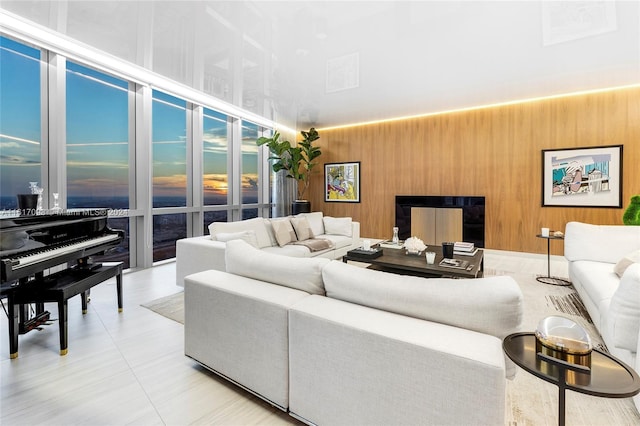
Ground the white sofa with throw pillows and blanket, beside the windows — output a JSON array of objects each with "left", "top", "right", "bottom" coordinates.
[{"left": 176, "top": 212, "right": 361, "bottom": 286}]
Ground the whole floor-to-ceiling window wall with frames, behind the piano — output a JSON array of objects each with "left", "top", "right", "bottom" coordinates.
[{"left": 0, "top": 37, "right": 269, "bottom": 267}]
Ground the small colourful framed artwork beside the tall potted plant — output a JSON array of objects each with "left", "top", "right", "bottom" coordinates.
[{"left": 324, "top": 161, "right": 360, "bottom": 203}]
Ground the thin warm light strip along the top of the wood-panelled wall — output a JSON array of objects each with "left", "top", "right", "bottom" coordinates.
[{"left": 317, "top": 83, "right": 640, "bottom": 131}]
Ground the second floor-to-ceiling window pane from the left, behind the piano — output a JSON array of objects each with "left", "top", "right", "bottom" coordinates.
[{"left": 65, "top": 61, "right": 131, "bottom": 266}]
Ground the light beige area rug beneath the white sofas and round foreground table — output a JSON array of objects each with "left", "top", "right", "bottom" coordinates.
[{"left": 142, "top": 270, "right": 640, "bottom": 426}]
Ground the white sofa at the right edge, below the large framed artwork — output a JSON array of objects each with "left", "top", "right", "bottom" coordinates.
[{"left": 564, "top": 222, "right": 640, "bottom": 410}]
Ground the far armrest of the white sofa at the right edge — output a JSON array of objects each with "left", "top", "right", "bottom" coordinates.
[{"left": 564, "top": 222, "right": 640, "bottom": 263}]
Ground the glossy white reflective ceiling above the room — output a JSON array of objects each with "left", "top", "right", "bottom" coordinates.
[{"left": 0, "top": 0, "right": 640, "bottom": 128}]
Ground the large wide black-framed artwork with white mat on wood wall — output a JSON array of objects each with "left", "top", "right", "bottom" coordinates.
[{"left": 542, "top": 145, "right": 622, "bottom": 208}]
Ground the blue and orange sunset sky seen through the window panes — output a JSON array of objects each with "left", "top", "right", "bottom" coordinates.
[{"left": 0, "top": 38, "right": 258, "bottom": 208}]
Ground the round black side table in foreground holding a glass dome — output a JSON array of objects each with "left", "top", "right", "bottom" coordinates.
[{"left": 502, "top": 333, "right": 640, "bottom": 426}]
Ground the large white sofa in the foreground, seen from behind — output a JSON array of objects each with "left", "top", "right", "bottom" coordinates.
[{"left": 184, "top": 240, "right": 522, "bottom": 425}]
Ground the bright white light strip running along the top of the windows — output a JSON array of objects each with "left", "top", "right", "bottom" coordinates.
[{"left": 0, "top": 9, "right": 276, "bottom": 128}]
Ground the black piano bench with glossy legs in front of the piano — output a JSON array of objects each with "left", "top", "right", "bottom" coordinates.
[{"left": 7, "top": 262, "right": 123, "bottom": 358}]
